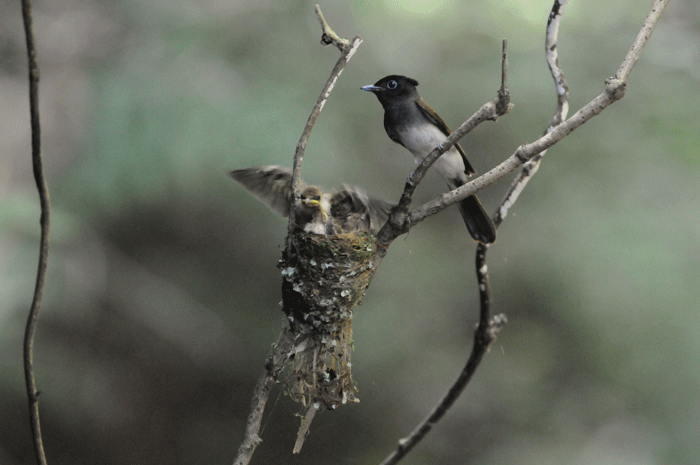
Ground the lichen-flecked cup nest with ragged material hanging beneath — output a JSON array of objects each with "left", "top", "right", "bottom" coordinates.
[{"left": 280, "top": 231, "right": 376, "bottom": 409}]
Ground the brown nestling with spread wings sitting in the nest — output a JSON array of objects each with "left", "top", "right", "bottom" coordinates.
[{"left": 229, "top": 166, "right": 393, "bottom": 236}]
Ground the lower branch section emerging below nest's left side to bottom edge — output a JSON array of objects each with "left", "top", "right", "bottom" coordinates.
[{"left": 233, "top": 328, "right": 294, "bottom": 465}]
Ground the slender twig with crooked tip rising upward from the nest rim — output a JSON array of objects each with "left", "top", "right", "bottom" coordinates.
[{"left": 287, "top": 5, "right": 362, "bottom": 250}]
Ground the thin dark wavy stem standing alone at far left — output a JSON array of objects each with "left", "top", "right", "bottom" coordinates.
[{"left": 22, "top": 0, "right": 50, "bottom": 465}]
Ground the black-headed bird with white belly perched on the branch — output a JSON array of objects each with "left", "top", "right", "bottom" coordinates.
[{"left": 362, "top": 75, "right": 496, "bottom": 244}]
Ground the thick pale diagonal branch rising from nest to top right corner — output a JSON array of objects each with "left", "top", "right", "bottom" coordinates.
[{"left": 406, "top": 0, "right": 669, "bottom": 226}]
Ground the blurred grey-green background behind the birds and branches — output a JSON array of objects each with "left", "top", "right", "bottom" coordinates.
[{"left": 0, "top": 0, "right": 700, "bottom": 465}]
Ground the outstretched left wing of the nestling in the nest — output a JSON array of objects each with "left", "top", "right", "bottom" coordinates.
[{"left": 229, "top": 166, "right": 305, "bottom": 217}]
